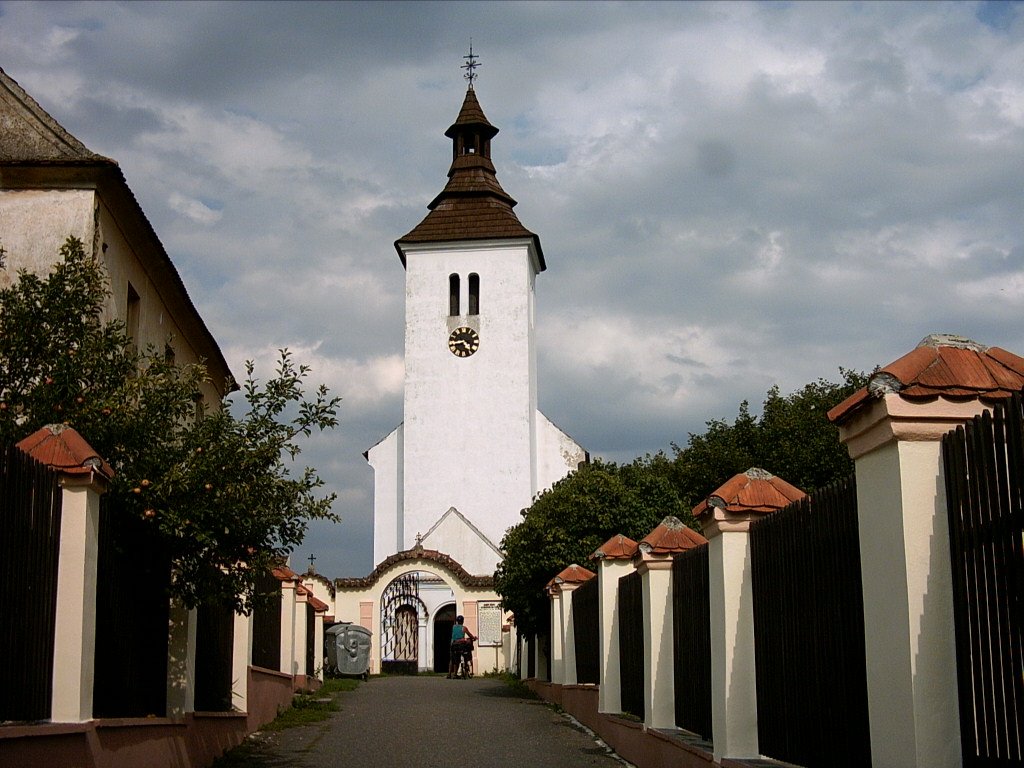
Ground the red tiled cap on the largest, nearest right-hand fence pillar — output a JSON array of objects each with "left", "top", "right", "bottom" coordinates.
[{"left": 828, "top": 334, "right": 1024, "bottom": 424}]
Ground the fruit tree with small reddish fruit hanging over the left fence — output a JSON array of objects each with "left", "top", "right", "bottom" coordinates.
[{"left": 0, "top": 238, "right": 340, "bottom": 610}]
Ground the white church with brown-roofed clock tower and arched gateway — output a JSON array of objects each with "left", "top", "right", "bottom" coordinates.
[{"left": 336, "top": 75, "right": 588, "bottom": 671}]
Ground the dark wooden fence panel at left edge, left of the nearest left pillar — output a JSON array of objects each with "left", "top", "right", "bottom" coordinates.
[{"left": 0, "top": 445, "right": 61, "bottom": 721}]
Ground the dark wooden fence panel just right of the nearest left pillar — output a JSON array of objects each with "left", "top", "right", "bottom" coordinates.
[{"left": 92, "top": 496, "right": 171, "bottom": 718}]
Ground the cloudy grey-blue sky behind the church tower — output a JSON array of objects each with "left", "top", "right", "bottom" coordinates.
[{"left": 0, "top": 2, "right": 1024, "bottom": 577}]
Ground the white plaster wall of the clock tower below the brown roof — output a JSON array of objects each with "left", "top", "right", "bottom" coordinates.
[{"left": 403, "top": 242, "right": 536, "bottom": 558}]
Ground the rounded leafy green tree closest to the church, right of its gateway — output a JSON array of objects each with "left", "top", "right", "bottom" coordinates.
[{"left": 495, "top": 454, "right": 694, "bottom": 634}]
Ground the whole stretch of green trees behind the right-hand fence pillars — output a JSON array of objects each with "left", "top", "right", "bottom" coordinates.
[{"left": 495, "top": 369, "right": 867, "bottom": 634}]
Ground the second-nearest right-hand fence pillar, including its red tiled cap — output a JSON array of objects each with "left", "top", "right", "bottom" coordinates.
[{"left": 696, "top": 468, "right": 805, "bottom": 761}]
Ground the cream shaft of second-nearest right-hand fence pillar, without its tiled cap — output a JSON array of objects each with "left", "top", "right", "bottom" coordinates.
[{"left": 703, "top": 514, "right": 759, "bottom": 762}]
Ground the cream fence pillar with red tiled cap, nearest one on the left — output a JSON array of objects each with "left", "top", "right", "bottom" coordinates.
[{"left": 17, "top": 424, "right": 114, "bottom": 723}]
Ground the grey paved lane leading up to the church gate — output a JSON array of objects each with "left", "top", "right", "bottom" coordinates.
[{"left": 223, "top": 676, "right": 628, "bottom": 768}]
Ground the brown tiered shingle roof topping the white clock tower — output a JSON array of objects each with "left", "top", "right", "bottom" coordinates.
[{"left": 394, "top": 87, "right": 546, "bottom": 271}]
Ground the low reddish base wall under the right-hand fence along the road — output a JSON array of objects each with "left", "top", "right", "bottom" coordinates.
[{"left": 526, "top": 678, "right": 716, "bottom": 768}]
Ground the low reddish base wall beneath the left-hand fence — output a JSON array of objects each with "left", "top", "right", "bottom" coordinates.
[{"left": 0, "top": 668, "right": 293, "bottom": 768}]
